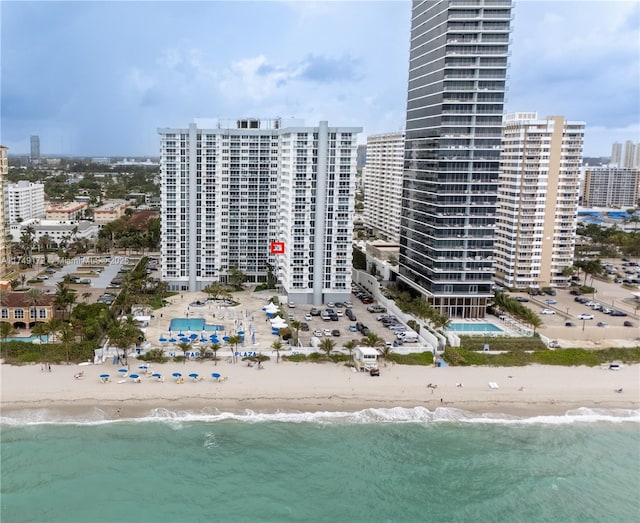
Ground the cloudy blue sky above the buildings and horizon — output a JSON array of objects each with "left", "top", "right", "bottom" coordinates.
[{"left": 0, "top": 0, "right": 640, "bottom": 156}]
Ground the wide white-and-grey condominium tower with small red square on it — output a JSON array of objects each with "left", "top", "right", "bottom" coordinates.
[{"left": 159, "top": 119, "right": 362, "bottom": 305}]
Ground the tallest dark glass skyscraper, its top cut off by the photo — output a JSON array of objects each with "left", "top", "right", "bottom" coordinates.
[{"left": 399, "top": 0, "right": 512, "bottom": 317}]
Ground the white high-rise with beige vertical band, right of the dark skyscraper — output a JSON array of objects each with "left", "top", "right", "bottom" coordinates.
[{"left": 495, "top": 113, "right": 584, "bottom": 289}]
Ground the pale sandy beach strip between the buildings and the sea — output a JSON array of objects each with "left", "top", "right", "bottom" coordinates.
[{"left": 0, "top": 360, "right": 640, "bottom": 417}]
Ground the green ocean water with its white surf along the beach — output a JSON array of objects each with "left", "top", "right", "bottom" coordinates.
[{"left": 0, "top": 408, "right": 640, "bottom": 523}]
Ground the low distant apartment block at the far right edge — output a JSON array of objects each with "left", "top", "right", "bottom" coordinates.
[{"left": 582, "top": 167, "right": 640, "bottom": 209}]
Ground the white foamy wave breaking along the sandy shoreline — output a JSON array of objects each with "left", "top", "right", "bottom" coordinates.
[{"left": 0, "top": 407, "right": 640, "bottom": 430}]
